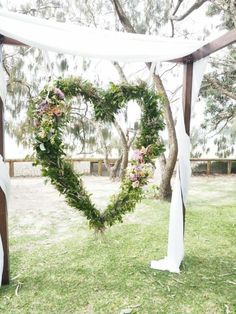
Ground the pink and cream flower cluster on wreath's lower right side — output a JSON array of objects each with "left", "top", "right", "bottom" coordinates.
[{"left": 127, "top": 147, "right": 153, "bottom": 188}]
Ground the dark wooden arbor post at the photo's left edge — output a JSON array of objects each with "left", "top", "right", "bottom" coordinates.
[{"left": 0, "top": 98, "right": 9, "bottom": 285}]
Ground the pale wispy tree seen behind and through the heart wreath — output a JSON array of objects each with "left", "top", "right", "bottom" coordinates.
[{"left": 4, "top": 0, "right": 144, "bottom": 177}]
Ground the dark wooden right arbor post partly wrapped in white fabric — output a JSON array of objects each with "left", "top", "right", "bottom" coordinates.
[{"left": 183, "top": 61, "right": 193, "bottom": 230}]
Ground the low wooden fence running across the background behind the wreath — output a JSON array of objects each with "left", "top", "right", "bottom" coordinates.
[{"left": 6, "top": 158, "right": 236, "bottom": 177}]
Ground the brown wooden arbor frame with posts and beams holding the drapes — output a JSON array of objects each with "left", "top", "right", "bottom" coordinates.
[{"left": 0, "top": 29, "right": 236, "bottom": 284}]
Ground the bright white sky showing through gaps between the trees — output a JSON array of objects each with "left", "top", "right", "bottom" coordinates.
[{"left": 0, "top": 0, "right": 230, "bottom": 158}]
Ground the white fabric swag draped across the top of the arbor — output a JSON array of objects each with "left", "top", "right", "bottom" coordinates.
[{"left": 0, "top": 9, "right": 203, "bottom": 62}]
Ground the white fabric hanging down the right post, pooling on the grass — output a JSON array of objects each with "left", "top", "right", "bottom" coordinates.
[{"left": 151, "top": 58, "right": 208, "bottom": 273}]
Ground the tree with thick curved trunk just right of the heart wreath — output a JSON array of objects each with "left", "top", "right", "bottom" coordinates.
[{"left": 111, "top": 0, "right": 214, "bottom": 199}]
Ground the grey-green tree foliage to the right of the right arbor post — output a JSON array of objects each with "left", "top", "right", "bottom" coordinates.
[{"left": 201, "top": 0, "right": 236, "bottom": 157}]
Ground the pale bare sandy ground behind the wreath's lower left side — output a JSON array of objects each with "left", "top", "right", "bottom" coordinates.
[{"left": 9, "top": 177, "right": 119, "bottom": 241}]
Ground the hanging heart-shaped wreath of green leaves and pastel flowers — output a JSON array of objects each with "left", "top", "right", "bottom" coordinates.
[{"left": 30, "top": 77, "right": 164, "bottom": 231}]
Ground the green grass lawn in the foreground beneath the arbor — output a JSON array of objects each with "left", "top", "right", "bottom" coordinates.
[{"left": 0, "top": 176, "right": 236, "bottom": 314}]
